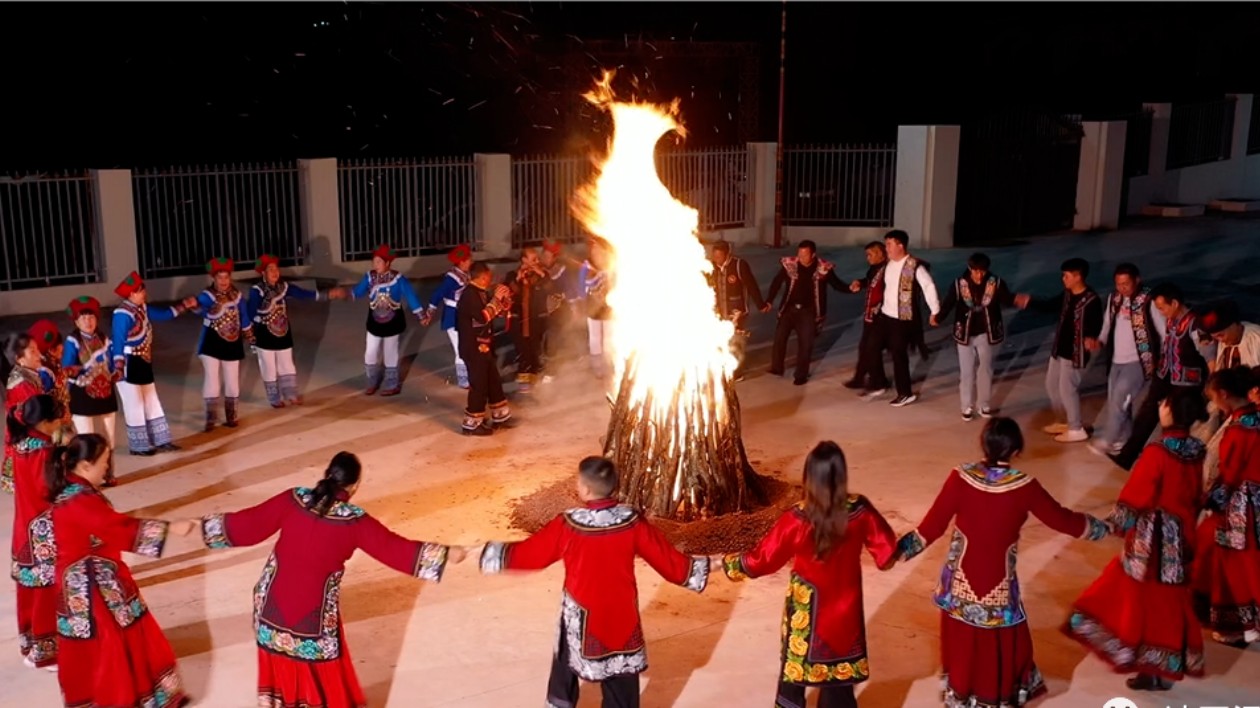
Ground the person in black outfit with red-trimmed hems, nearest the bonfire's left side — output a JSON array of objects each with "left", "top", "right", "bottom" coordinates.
[{"left": 455, "top": 262, "right": 512, "bottom": 436}]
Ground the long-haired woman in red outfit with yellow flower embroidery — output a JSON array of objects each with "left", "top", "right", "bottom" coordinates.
[{"left": 723, "top": 441, "right": 897, "bottom": 708}]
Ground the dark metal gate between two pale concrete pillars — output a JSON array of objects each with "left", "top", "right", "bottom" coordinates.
[{"left": 954, "top": 110, "right": 1084, "bottom": 244}]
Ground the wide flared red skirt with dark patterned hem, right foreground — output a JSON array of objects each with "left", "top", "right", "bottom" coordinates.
[{"left": 1066, "top": 558, "right": 1203, "bottom": 680}]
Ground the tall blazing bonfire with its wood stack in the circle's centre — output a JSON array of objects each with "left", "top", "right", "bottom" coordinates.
[{"left": 573, "top": 72, "right": 760, "bottom": 520}]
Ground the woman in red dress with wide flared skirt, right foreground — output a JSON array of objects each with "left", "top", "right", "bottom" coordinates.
[{"left": 1067, "top": 391, "right": 1207, "bottom": 690}]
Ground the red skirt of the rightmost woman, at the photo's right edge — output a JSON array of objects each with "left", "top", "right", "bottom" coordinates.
[{"left": 1193, "top": 514, "right": 1260, "bottom": 629}]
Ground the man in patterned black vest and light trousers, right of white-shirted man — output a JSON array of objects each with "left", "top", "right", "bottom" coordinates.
[{"left": 931, "top": 253, "right": 1016, "bottom": 421}]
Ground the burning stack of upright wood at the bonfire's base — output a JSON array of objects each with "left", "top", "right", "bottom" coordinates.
[{"left": 604, "top": 357, "right": 766, "bottom": 522}]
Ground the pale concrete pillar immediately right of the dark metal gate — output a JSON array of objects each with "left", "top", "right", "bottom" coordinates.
[{"left": 1072, "top": 121, "right": 1128, "bottom": 231}]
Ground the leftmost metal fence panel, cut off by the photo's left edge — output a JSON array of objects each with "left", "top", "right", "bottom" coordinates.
[{"left": 0, "top": 171, "right": 102, "bottom": 291}]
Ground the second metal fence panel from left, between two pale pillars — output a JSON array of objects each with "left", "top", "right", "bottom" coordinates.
[{"left": 131, "top": 163, "right": 307, "bottom": 277}]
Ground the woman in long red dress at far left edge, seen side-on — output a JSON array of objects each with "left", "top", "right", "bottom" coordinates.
[{"left": 6, "top": 394, "right": 60, "bottom": 670}]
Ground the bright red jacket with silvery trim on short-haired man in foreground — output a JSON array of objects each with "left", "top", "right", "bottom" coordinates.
[{"left": 481, "top": 499, "right": 708, "bottom": 682}]
